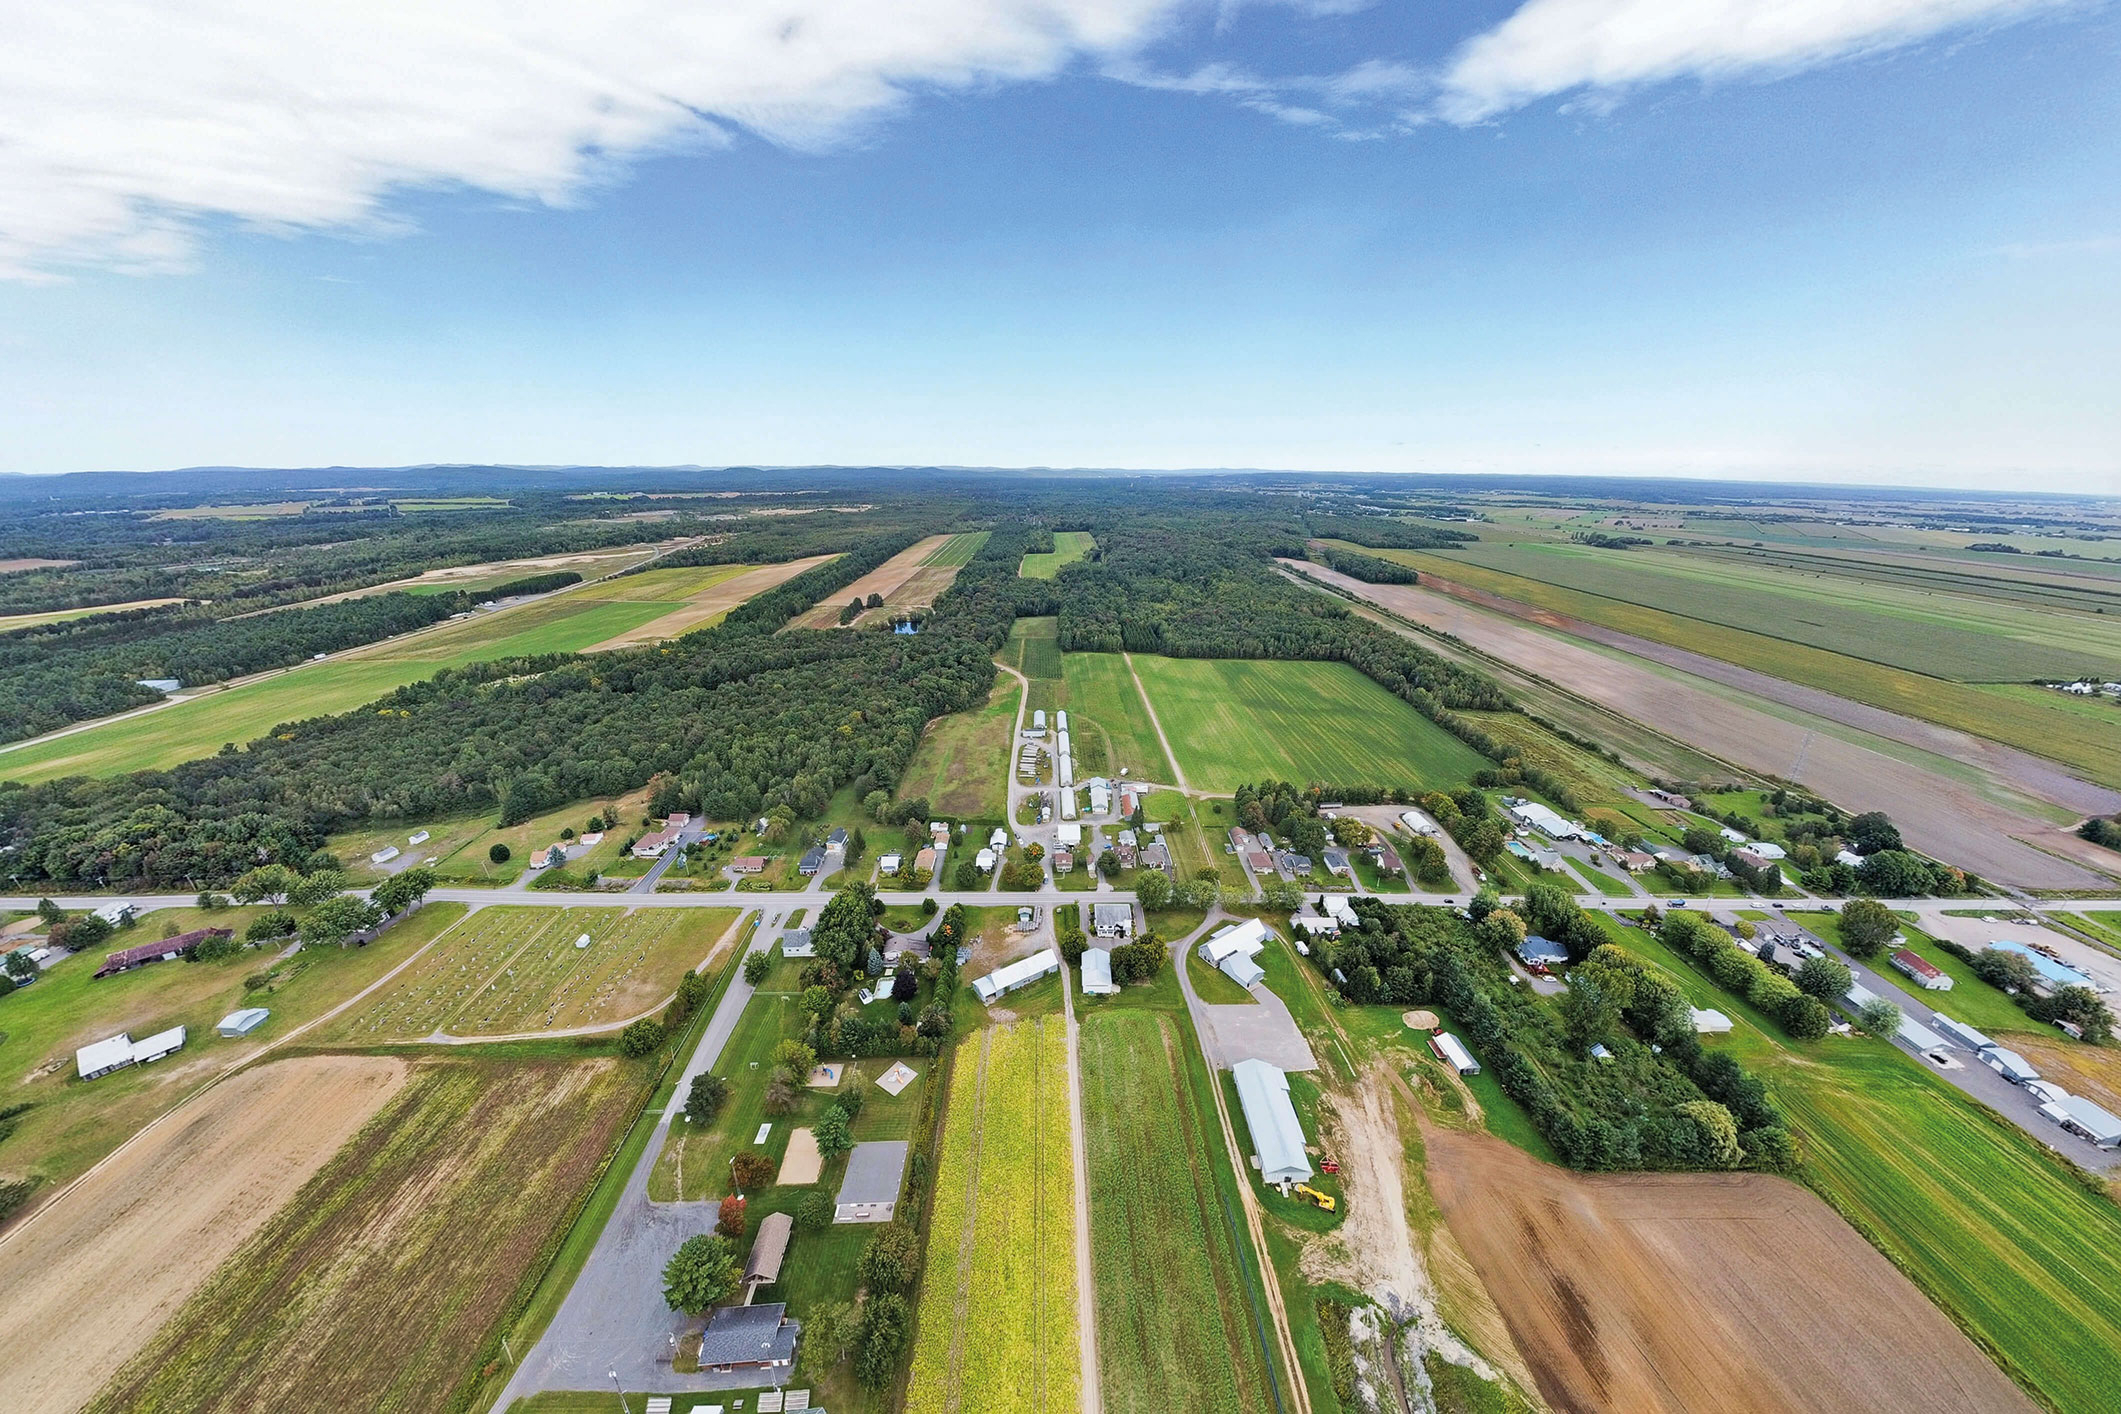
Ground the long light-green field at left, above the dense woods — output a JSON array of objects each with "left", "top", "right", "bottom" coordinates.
[{"left": 0, "top": 564, "right": 757, "bottom": 782}]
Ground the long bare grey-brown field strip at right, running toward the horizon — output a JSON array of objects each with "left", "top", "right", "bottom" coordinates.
[{"left": 1281, "top": 566, "right": 2121, "bottom": 888}]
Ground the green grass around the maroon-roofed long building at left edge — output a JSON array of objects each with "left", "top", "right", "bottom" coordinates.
[{"left": 0, "top": 903, "right": 464, "bottom": 1191}]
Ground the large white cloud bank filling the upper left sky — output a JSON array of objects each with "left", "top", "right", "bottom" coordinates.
[{"left": 0, "top": 0, "right": 1184, "bottom": 278}]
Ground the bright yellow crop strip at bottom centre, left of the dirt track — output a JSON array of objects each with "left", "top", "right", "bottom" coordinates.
[{"left": 906, "top": 1018, "right": 1082, "bottom": 1414}]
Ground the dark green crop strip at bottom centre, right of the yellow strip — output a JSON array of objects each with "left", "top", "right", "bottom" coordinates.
[{"left": 1082, "top": 1011, "right": 1270, "bottom": 1414}]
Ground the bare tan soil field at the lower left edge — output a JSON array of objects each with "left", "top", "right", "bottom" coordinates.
[{"left": 0, "top": 1056, "right": 407, "bottom": 1414}]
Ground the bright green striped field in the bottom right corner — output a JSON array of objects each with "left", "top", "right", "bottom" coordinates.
[{"left": 1765, "top": 1041, "right": 2121, "bottom": 1414}]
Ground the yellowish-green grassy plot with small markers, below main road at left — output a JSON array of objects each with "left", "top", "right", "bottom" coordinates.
[{"left": 331, "top": 907, "right": 736, "bottom": 1043}]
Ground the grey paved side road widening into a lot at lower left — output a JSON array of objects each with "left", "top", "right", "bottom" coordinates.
[{"left": 494, "top": 926, "right": 778, "bottom": 1410}]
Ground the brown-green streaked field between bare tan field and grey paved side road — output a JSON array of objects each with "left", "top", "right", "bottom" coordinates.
[{"left": 89, "top": 1060, "right": 645, "bottom": 1414}]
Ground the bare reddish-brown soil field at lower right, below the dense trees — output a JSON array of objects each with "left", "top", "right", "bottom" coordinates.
[{"left": 1427, "top": 1130, "right": 2034, "bottom": 1414}]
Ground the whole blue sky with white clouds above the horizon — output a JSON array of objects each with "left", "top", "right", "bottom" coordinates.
[{"left": 0, "top": 0, "right": 2121, "bottom": 494}]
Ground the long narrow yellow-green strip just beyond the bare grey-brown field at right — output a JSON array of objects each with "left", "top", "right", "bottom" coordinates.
[{"left": 1340, "top": 549, "right": 2121, "bottom": 786}]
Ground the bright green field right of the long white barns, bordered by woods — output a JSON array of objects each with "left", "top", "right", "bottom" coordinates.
[{"left": 1135, "top": 653, "right": 1487, "bottom": 791}]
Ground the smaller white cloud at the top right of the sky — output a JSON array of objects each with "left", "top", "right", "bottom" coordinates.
[{"left": 1436, "top": 0, "right": 2057, "bottom": 123}]
